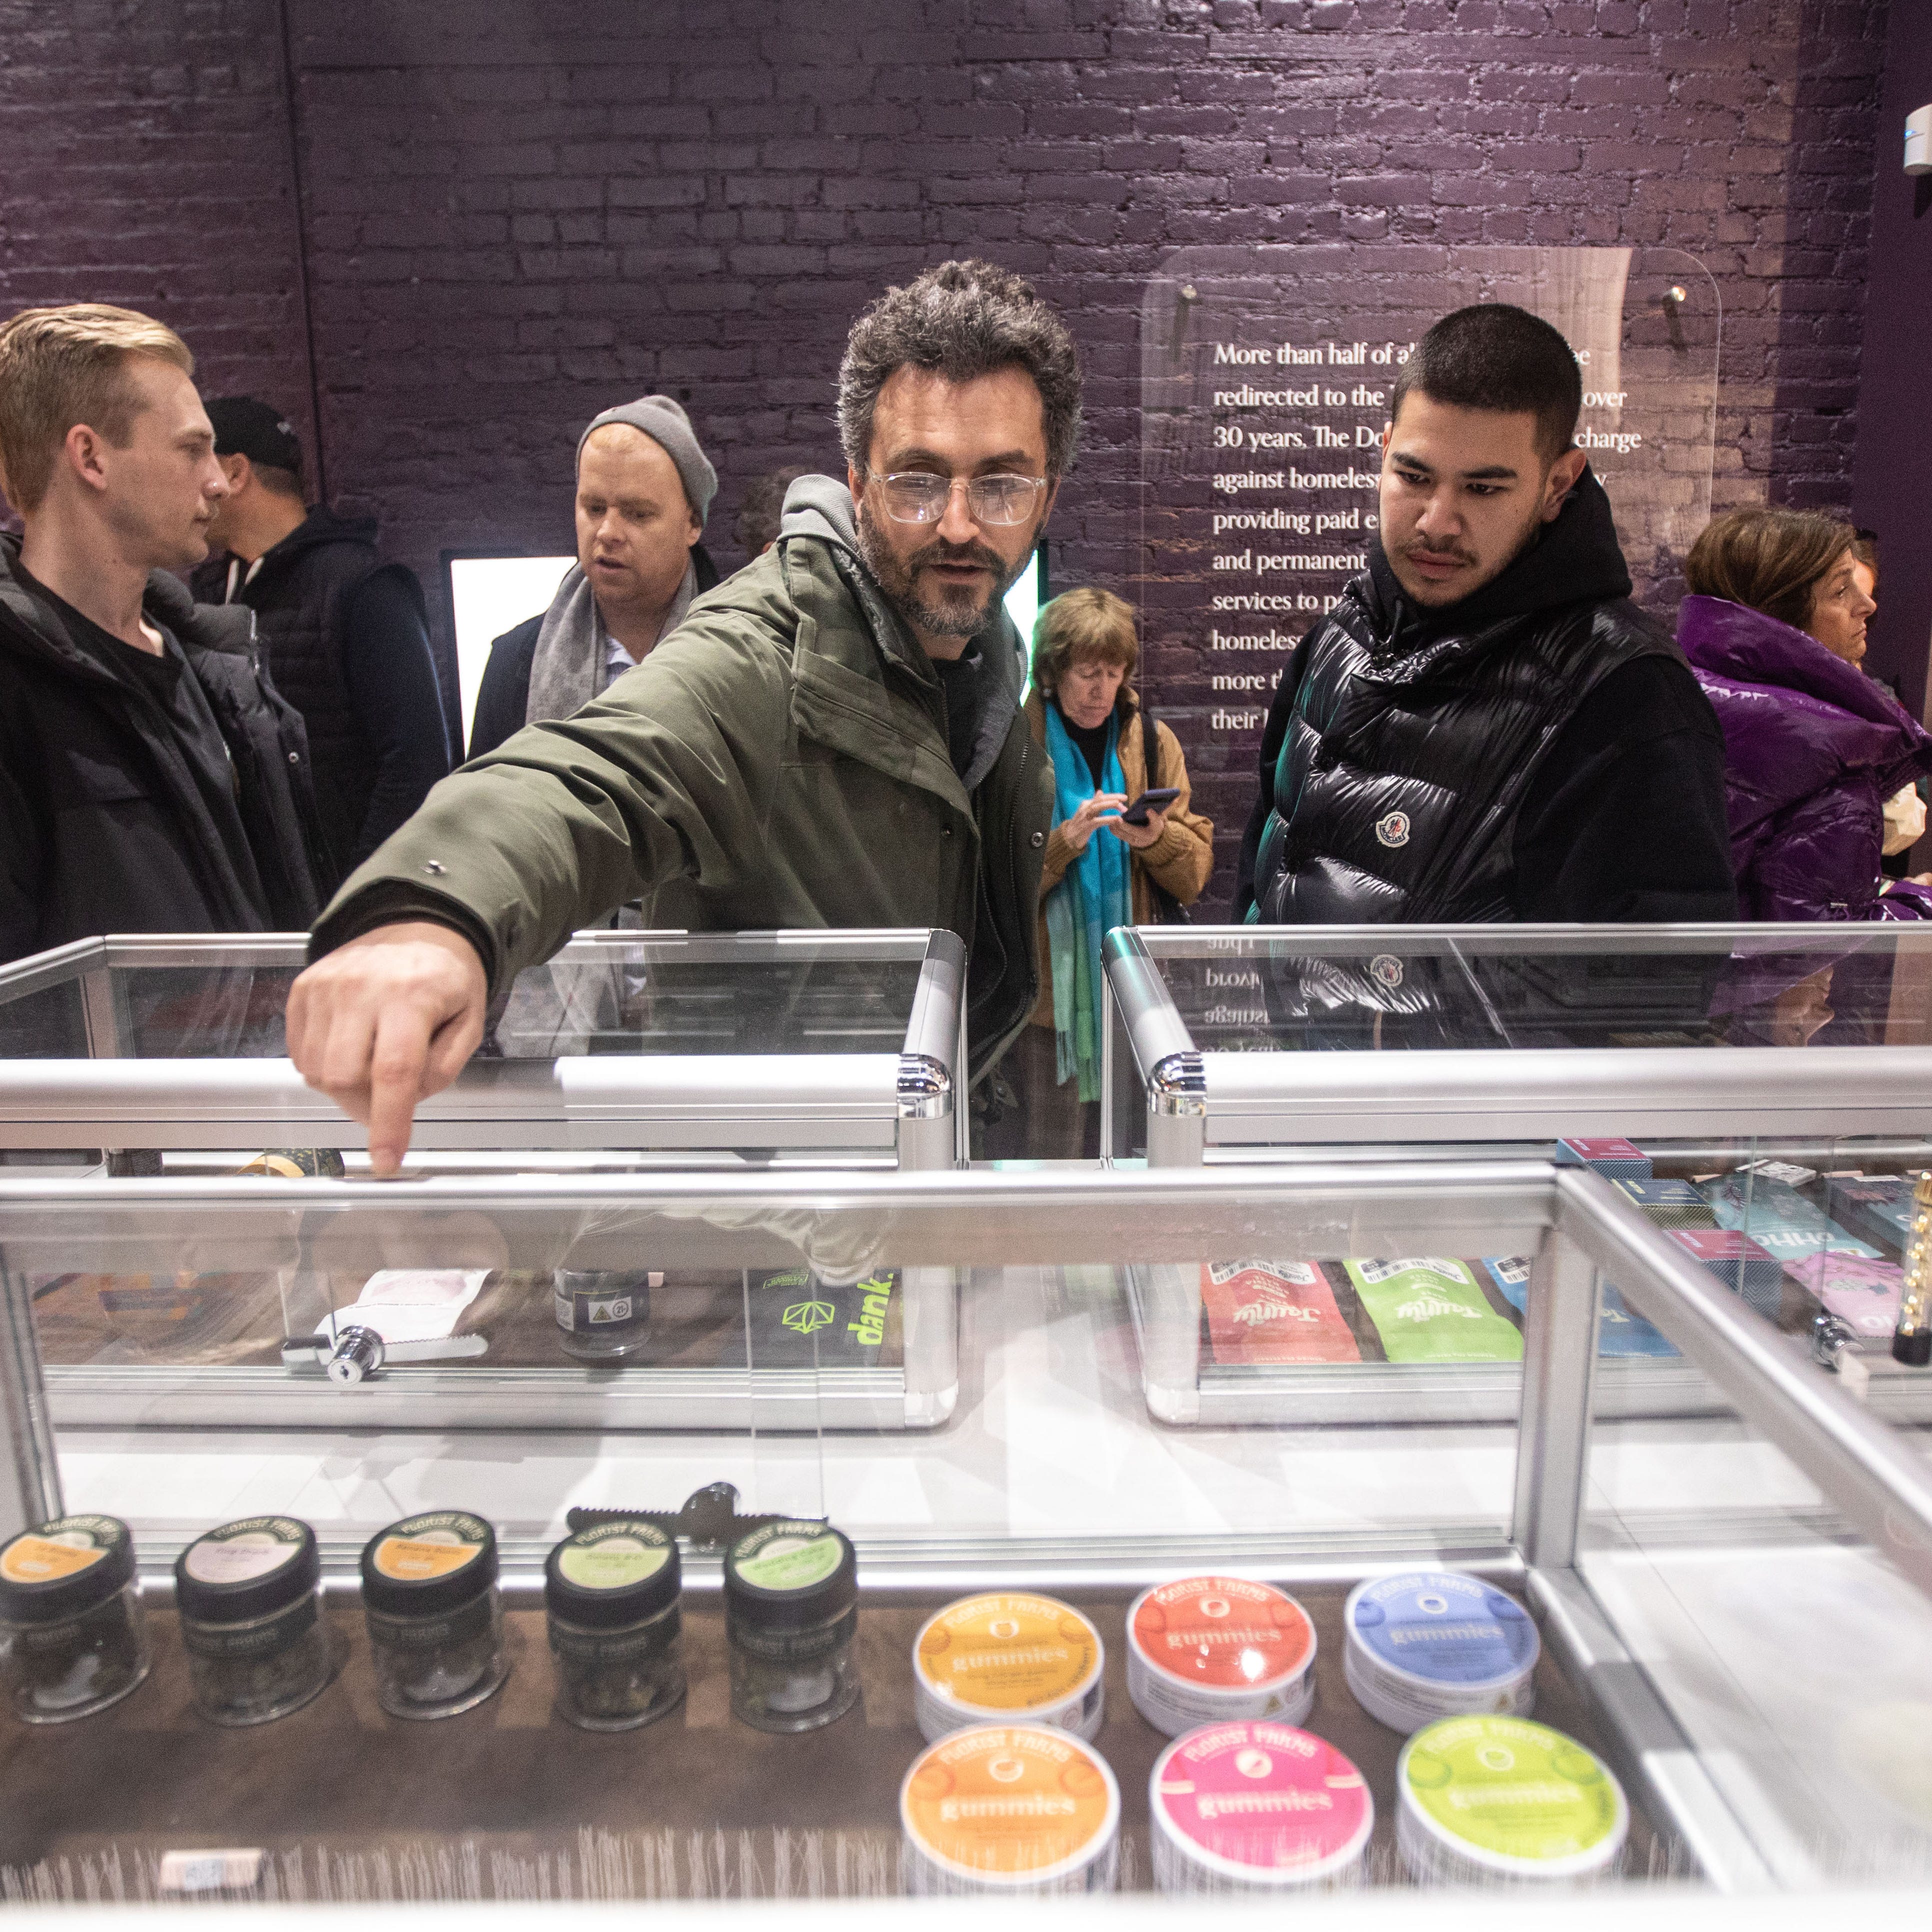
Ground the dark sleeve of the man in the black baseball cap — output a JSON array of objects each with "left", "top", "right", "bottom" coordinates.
[{"left": 342, "top": 568, "right": 450, "bottom": 866}]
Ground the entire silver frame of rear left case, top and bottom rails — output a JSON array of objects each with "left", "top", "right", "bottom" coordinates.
[{"left": 0, "top": 930, "right": 968, "bottom": 1430}]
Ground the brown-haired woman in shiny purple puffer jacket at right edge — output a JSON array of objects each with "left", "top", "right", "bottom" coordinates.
[{"left": 1677, "top": 510, "right": 1932, "bottom": 920}]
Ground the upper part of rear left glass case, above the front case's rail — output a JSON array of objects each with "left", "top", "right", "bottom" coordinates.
[{"left": 0, "top": 931, "right": 966, "bottom": 1172}]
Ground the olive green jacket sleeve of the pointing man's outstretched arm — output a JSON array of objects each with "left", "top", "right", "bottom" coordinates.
[{"left": 309, "top": 612, "right": 788, "bottom": 993}]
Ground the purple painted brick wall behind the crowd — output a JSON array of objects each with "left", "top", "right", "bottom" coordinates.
[{"left": 0, "top": 0, "right": 1890, "bottom": 896}]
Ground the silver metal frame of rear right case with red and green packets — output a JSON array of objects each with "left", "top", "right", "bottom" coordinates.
[{"left": 1101, "top": 926, "right": 1932, "bottom": 1424}]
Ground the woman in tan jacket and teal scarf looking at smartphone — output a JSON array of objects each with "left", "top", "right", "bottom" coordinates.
[{"left": 986, "top": 590, "right": 1214, "bottom": 1159}]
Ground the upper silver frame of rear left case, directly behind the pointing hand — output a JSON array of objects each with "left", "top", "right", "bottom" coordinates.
[{"left": 0, "top": 928, "right": 966, "bottom": 1169}]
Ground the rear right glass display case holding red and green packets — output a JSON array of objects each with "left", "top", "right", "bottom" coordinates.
[{"left": 1103, "top": 926, "right": 1932, "bottom": 1422}]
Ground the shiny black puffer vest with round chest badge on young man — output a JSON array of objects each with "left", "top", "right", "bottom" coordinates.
[{"left": 1254, "top": 578, "right": 1675, "bottom": 926}]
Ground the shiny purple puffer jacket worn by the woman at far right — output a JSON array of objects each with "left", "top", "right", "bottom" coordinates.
[{"left": 1677, "top": 597, "right": 1932, "bottom": 920}]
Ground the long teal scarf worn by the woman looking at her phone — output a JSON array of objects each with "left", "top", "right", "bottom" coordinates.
[{"left": 1047, "top": 698, "right": 1134, "bottom": 1101}]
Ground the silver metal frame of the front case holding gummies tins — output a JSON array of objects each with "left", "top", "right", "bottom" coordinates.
[{"left": 0, "top": 1161, "right": 1932, "bottom": 1890}]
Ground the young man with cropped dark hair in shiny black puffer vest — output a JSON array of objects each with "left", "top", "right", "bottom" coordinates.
[{"left": 1236, "top": 304, "right": 1737, "bottom": 926}]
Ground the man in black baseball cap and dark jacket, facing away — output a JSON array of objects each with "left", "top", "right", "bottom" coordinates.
[{"left": 193, "top": 396, "right": 450, "bottom": 890}]
